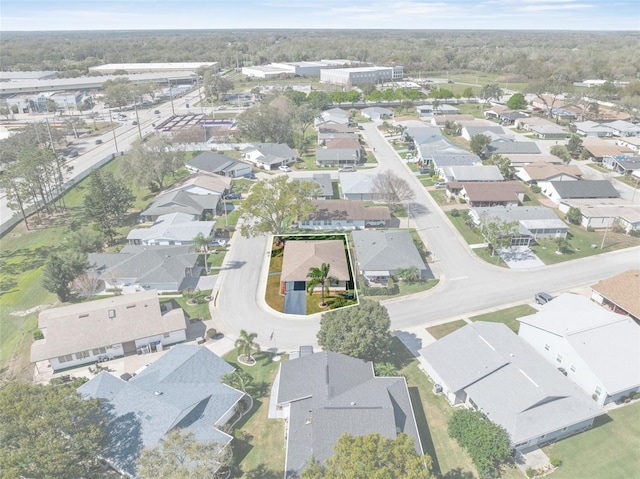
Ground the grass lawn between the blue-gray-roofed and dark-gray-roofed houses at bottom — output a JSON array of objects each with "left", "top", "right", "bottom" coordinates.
[{"left": 223, "top": 351, "right": 285, "bottom": 479}]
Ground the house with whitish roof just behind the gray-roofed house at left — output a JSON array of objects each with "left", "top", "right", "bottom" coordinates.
[{"left": 127, "top": 213, "right": 215, "bottom": 245}]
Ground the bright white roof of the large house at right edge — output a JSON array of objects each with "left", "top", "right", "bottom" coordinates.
[{"left": 519, "top": 293, "right": 640, "bottom": 395}]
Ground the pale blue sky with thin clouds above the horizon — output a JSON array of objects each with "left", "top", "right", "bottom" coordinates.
[{"left": 0, "top": 0, "right": 640, "bottom": 31}]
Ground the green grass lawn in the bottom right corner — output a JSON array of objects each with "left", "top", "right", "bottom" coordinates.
[{"left": 543, "top": 402, "right": 640, "bottom": 479}]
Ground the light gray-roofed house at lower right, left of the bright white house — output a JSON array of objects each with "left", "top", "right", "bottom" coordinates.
[{"left": 418, "top": 322, "right": 605, "bottom": 450}]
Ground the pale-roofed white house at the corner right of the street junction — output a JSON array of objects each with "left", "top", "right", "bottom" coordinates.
[{"left": 469, "top": 206, "right": 569, "bottom": 246}]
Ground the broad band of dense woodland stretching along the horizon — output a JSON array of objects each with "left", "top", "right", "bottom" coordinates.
[{"left": 0, "top": 30, "right": 640, "bottom": 82}]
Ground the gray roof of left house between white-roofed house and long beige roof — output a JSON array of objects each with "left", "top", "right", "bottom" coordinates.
[{"left": 87, "top": 245, "right": 199, "bottom": 283}]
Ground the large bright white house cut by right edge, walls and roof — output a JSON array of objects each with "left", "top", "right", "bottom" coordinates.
[{"left": 518, "top": 293, "right": 640, "bottom": 406}]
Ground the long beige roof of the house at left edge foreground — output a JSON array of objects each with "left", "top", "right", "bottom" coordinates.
[{"left": 31, "top": 290, "right": 187, "bottom": 362}]
